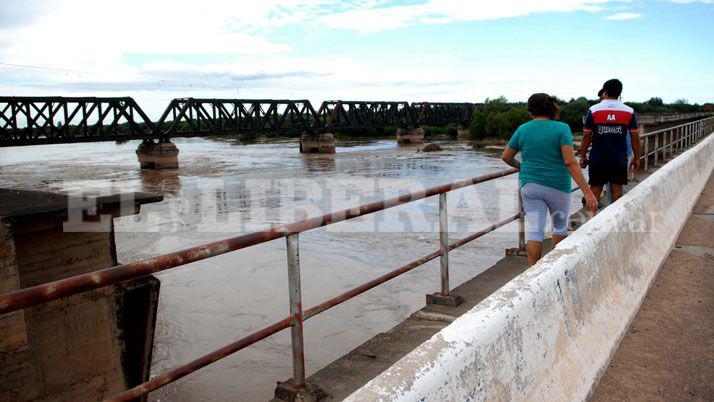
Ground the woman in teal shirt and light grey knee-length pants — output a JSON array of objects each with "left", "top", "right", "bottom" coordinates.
[{"left": 501, "top": 93, "right": 597, "bottom": 267}]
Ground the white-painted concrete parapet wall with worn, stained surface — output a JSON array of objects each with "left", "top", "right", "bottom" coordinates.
[{"left": 347, "top": 135, "right": 714, "bottom": 401}]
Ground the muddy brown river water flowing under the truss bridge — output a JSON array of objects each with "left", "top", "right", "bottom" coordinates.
[{"left": 0, "top": 139, "right": 576, "bottom": 401}]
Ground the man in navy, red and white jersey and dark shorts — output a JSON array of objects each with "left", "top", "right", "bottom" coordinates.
[{"left": 580, "top": 79, "right": 640, "bottom": 202}]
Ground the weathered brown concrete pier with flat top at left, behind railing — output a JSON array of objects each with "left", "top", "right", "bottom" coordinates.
[{"left": 0, "top": 190, "right": 161, "bottom": 401}]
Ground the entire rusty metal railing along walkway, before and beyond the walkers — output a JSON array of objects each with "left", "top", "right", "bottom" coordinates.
[{"left": 0, "top": 114, "right": 714, "bottom": 401}]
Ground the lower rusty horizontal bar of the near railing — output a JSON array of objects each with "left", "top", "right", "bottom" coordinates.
[{"left": 109, "top": 214, "right": 520, "bottom": 402}]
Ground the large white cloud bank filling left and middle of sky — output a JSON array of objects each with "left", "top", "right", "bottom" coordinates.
[{"left": 0, "top": 0, "right": 714, "bottom": 107}]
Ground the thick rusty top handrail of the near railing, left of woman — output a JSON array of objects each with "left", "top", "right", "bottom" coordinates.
[{"left": 0, "top": 168, "right": 518, "bottom": 314}]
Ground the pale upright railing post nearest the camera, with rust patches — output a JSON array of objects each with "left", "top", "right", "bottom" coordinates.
[{"left": 286, "top": 233, "right": 305, "bottom": 388}]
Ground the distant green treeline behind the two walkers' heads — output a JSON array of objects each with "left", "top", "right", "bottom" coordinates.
[{"left": 470, "top": 97, "right": 711, "bottom": 140}]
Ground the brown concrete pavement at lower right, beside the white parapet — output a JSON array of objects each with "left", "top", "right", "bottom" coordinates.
[{"left": 592, "top": 175, "right": 714, "bottom": 402}]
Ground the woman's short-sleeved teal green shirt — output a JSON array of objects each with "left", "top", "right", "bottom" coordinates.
[{"left": 508, "top": 120, "right": 573, "bottom": 193}]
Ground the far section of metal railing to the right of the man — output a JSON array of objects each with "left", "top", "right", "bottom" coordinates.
[{"left": 640, "top": 117, "right": 714, "bottom": 171}]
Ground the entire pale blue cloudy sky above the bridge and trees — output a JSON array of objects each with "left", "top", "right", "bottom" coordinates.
[{"left": 0, "top": 0, "right": 714, "bottom": 117}]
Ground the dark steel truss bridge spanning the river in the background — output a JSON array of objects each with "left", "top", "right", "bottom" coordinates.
[{"left": 0, "top": 97, "right": 482, "bottom": 146}]
